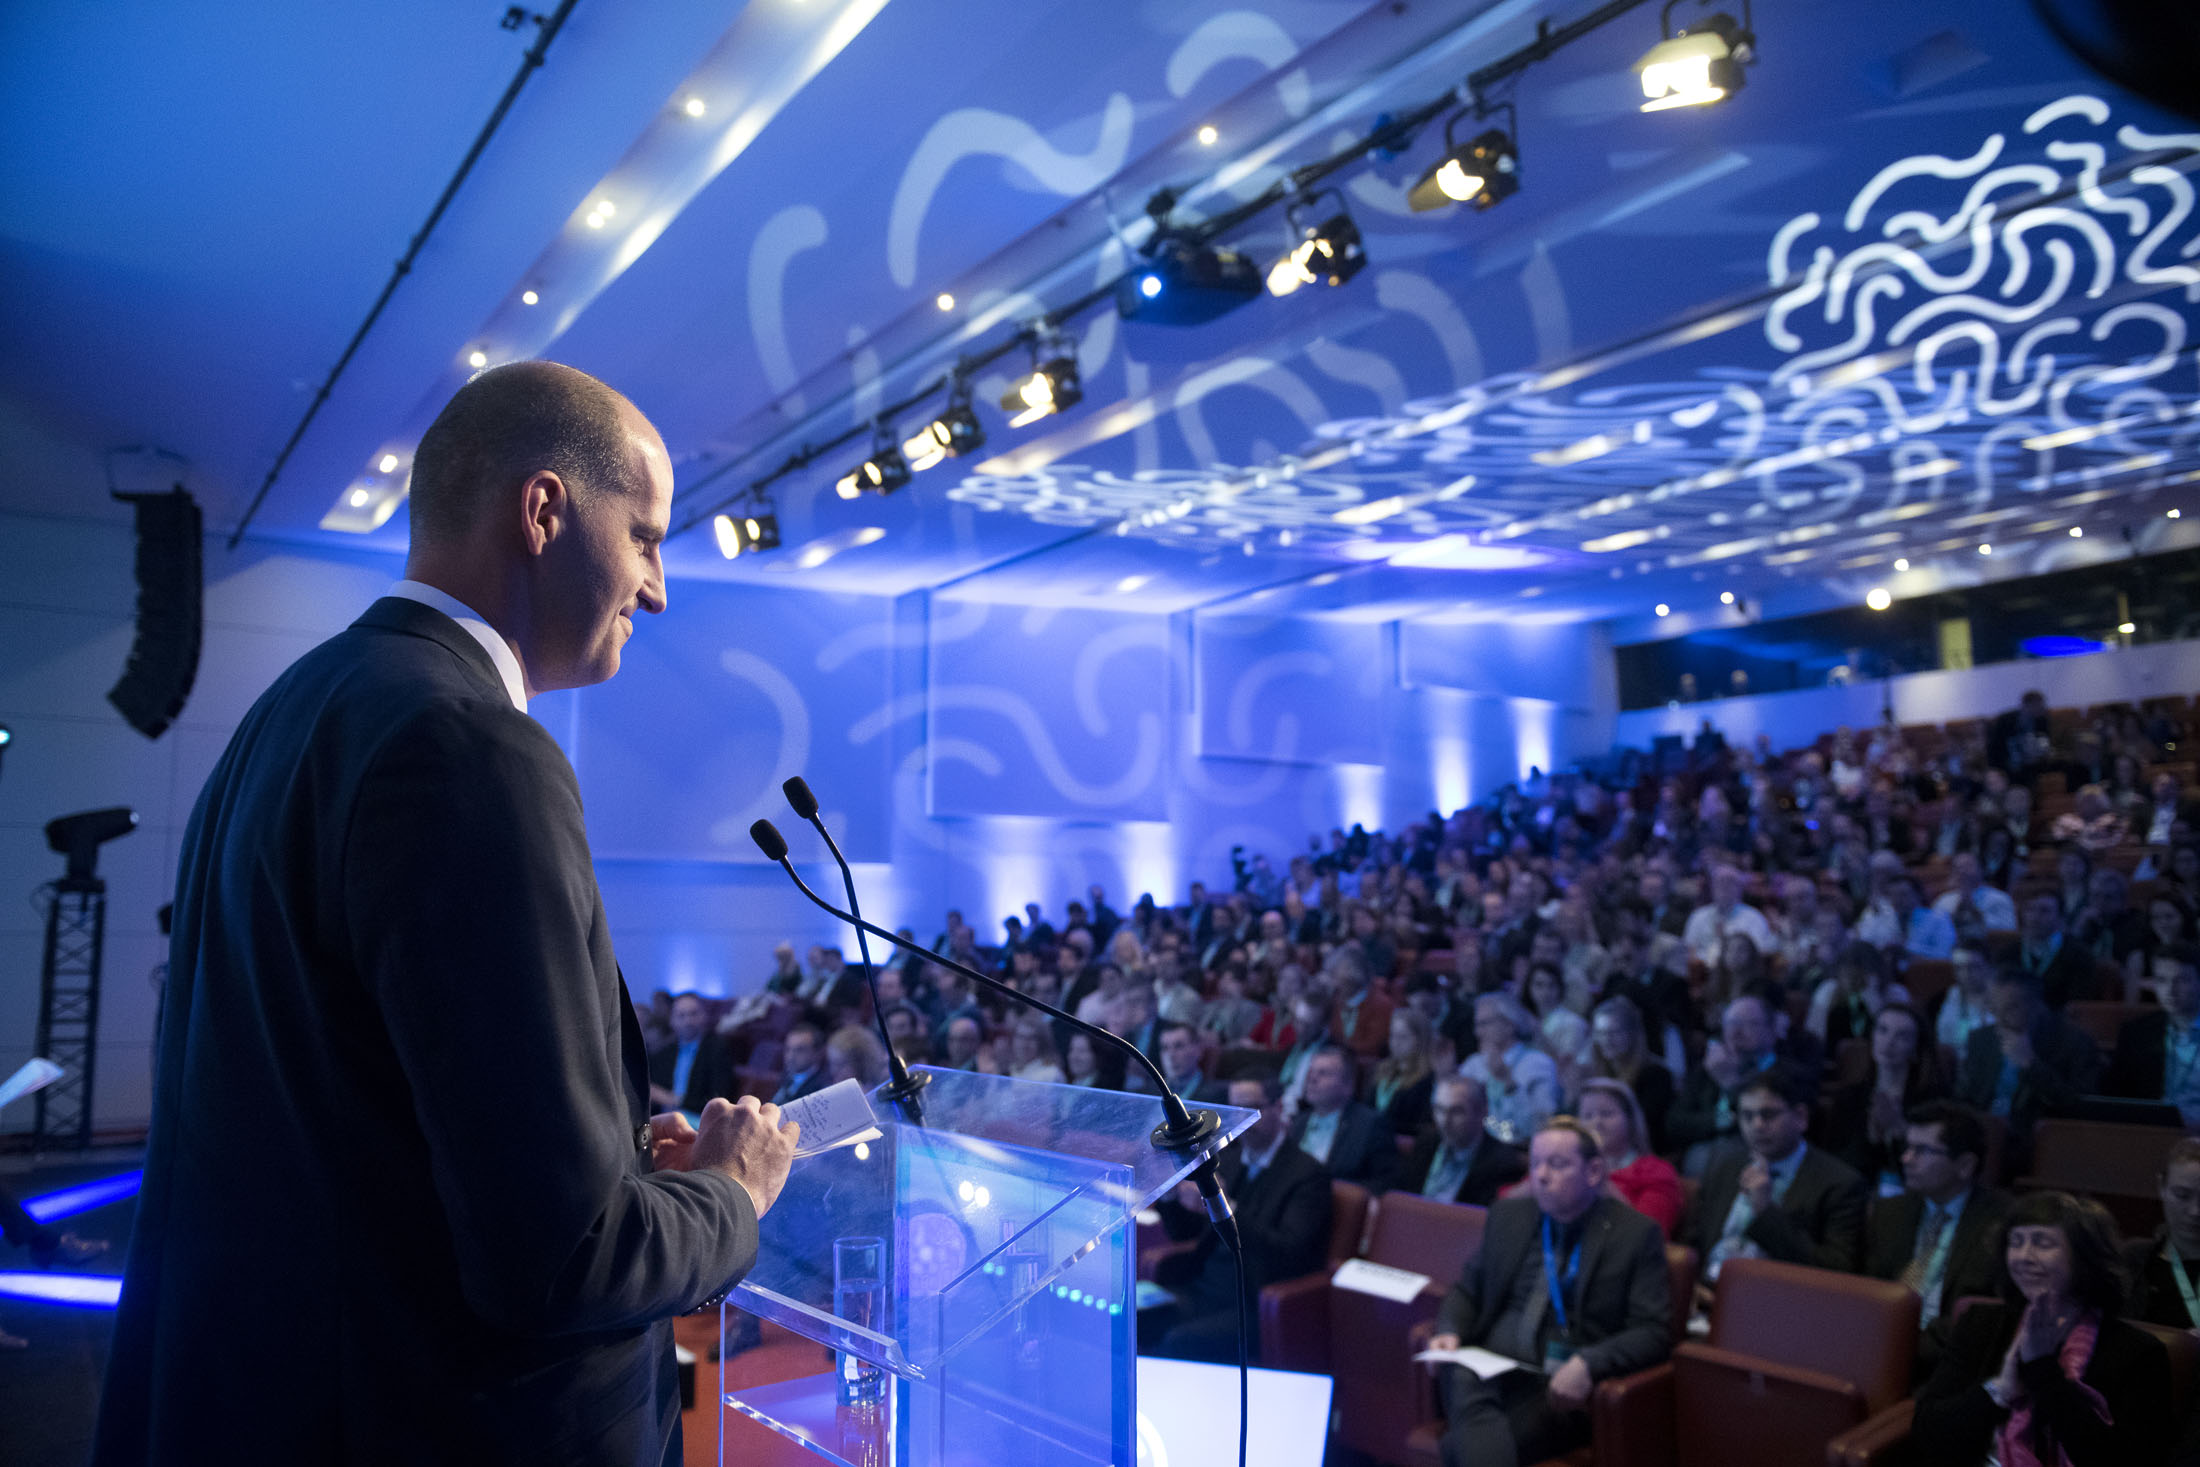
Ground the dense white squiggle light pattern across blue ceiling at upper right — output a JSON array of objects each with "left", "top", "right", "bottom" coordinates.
[{"left": 953, "top": 95, "right": 2200, "bottom": 565}]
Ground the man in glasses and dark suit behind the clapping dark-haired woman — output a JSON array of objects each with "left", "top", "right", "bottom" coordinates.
[{"left": 1863, "top": 1100, "right": 2009, "bottom": 1381}]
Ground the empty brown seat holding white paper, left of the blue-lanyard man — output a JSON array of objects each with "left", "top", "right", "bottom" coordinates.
[{"left": 1261, "top": 1192, "right": 1485, "bottom": 1463}]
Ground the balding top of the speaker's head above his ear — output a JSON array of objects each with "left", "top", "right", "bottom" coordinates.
[{"left": 411, "top": 361, "right": 656, "bottom": 545}]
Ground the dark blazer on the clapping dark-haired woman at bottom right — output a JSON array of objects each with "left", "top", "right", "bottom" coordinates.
[{"left": 1910, "top": 1300, "right": 2171, "bottom": 1467}]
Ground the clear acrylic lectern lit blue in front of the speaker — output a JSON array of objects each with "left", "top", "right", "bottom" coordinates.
[{"left": 719, "top": 1067, "right": 1254, "bottom": 1467}]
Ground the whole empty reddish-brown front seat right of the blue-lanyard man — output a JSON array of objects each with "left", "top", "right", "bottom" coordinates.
[{"left": 1593, "top": 1258, "right": 1918, "bottom": 1467}]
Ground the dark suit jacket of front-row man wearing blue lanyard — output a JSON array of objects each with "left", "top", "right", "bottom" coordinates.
[{"left": 1437, "top": 1196, "right": 1672, "bottom": 1381}]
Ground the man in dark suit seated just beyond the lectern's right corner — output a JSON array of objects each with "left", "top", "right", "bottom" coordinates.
[{"left": 1137, "top": 1076, "right": 1329, "bottom": 1364}]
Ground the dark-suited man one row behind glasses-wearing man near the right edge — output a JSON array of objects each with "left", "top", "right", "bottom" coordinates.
[{"left": 1956, "top": 968, "right": 2101, "bottom": 1177}]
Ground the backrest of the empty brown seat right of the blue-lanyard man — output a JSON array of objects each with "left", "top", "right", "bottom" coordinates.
[{"left": 1709, "top": 1258, "right": 1918, "bottom": 1412}]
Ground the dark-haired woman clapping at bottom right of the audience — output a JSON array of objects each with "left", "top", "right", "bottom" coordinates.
[{"left": 1910, "top": 1192, "right": 2171, "bottom": 1467}]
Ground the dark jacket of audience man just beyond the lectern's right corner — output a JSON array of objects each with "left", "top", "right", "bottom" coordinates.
[{"left": 1155, "top": 1141, "right": 1331, "bottom": 1309}]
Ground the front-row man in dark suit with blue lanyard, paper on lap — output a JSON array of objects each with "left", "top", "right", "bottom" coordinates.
[{"left": 1428, "top": 1115, "right": 1672, "bottom": 1467}]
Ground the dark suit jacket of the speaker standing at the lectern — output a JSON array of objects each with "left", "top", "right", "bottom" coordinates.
[{"left": 92, "top": 598, "right": 757, "bottom": 1467}]
